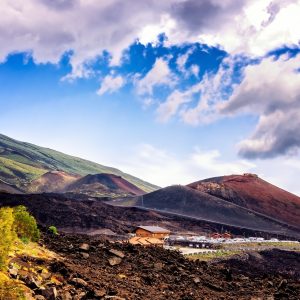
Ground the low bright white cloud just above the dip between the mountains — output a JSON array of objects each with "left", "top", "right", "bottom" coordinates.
[{"left": 119, "top": 144, "right": 255, "bottom": 186}]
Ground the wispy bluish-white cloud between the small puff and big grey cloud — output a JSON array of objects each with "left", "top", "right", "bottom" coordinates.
[{"left": 157, "top": 57, "right": 239, "bottom": 125}]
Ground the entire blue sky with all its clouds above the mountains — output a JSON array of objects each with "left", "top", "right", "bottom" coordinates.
[{"left": 0, "top": 0, "right": 300, "bottom": 194}]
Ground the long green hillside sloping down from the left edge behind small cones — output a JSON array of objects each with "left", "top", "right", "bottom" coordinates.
[{"left": 0, "top": 134, "right": 158, "bottom": 192}]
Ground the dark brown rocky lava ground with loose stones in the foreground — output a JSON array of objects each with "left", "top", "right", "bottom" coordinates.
[{"left": 10, "top": 234, "right": 300, "bottom": 300}]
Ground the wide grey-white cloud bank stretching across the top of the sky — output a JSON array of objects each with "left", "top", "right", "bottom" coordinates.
[{"left": 0, "top": 0, "right": 300, "bottom": 79}]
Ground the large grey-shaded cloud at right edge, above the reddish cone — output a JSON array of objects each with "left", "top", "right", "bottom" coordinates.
[{"left": 219, "top": 56, "right": 300, "bottom": 158}]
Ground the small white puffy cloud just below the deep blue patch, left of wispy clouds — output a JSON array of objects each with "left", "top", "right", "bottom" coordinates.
[{"left": 136, "top": 58, "right": 176, "bottom": 96}]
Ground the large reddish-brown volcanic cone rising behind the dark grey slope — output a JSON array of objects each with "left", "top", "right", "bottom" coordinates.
[{"left": 188, "top": 174, "right": 300, "bottom": 228}]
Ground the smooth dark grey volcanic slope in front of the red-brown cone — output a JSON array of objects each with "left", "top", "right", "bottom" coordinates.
[{"left": 111, "top": 186, "right": 299, "bottom": 236}]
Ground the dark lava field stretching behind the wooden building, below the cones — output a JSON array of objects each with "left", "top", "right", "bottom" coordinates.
[{"left": 0, "top": 193, "right": 293, "bottom": 239}]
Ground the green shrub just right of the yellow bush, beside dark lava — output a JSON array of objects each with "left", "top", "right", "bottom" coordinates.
[{"left": 13, "top": 206, "right": 40, "bottom": 242}]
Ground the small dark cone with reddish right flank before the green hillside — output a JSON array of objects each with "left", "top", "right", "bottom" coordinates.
[{"left": 64, "top": 173, "right": 145, "bottom": 197}]
